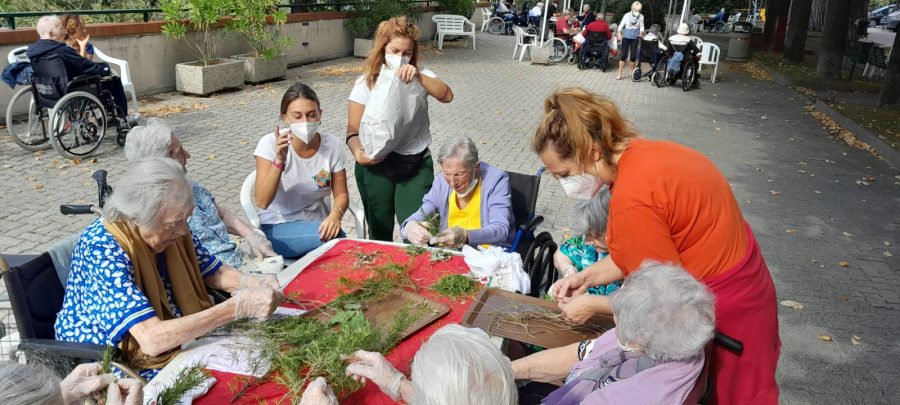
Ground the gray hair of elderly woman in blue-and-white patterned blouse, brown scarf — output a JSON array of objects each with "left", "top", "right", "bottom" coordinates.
[{"left": 103, "top": 159, "right": 194, "bottom": 228}]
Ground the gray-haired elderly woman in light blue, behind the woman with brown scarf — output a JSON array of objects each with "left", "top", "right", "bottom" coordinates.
[{"left": 125, "top": 118, "right": 277, "bottom": 271}]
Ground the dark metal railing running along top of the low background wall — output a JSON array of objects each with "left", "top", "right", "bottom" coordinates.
[{"left": 0, "top": 0, "right": 438, "bottom": 30}]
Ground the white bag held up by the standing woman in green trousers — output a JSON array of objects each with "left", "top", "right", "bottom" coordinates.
[{"left": 359, "top": 66, "right": 429, "bottom": 159}]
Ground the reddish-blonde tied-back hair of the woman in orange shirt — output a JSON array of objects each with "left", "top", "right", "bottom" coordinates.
[{"left": 531, "top": 87, "right": 641, "bottom": 166}]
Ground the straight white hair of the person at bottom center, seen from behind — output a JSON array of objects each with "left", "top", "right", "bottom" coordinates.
[{"left": 410, "top": 324, "right": 518, "bottom": 405}]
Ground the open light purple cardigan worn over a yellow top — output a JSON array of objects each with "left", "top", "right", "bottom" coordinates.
[{"left": 400, "top": 162, "right": 516, "bottom": 246}]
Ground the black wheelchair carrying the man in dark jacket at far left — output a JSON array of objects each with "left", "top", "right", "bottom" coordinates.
[{"left": 19, "top": 50, "right": 131, "bottom": 159}]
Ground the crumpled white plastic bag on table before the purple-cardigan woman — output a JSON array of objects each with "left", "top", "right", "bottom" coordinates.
[{"left": 462, "top": 245, "right": 531, "bottom": 294}]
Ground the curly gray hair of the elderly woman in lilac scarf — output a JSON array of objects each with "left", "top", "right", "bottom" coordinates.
[{"left": 610, "top": 261, "right": 716, "bottom": 361}]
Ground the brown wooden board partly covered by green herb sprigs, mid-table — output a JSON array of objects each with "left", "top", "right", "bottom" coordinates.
[{"left": 303, "top": 289, "right": 450, "bottom": 341}]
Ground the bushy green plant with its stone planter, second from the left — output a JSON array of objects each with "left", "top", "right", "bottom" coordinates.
[{"left": 225, "top": 0, "right": 292, "bottom": 83}]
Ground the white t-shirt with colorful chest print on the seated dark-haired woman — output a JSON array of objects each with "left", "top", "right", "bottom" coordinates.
[{"left": 253, "top": 132, "right": 348, "bottom": 224}]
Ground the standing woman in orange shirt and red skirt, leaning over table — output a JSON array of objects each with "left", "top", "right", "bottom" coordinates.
[{"left": 532, "top": 88, "right": 781, "bottom": 404}]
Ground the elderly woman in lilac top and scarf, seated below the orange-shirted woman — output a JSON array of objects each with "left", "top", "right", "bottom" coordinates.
[{"left": 512, "top": 262, "right": 715, "bottom": 404}]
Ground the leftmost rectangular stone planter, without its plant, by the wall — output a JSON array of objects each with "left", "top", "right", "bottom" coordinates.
[{"left": 175, "top": 58, "right": 244, "bottom": 96}]
